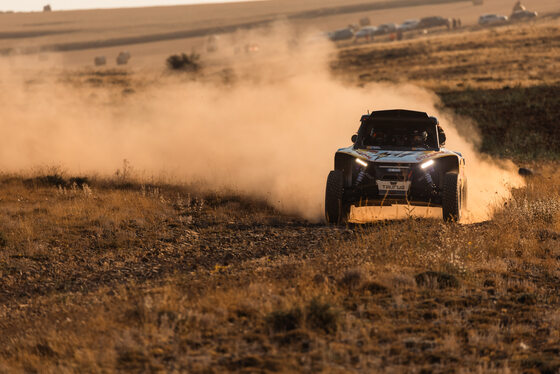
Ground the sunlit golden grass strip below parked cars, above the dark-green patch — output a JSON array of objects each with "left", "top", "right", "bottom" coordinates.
[{"left": 334, "top": 22, "right": 560, "bottom": 92}]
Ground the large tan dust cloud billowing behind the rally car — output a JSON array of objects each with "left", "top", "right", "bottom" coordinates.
[{"left": 0, "top": 30, "right": 522, "bottom": 225}]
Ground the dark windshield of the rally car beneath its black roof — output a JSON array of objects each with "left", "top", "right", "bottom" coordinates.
[{"left": 361, "top": 123, "right": 438, "bottom": 150}]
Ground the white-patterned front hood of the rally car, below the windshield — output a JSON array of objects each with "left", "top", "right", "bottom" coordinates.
[{"left": 337, "top": 147, "right": 461, "bottom": 163}]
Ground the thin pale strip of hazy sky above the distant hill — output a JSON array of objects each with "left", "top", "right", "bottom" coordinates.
[{"left": 0, "top": 0, "right": 249, "bottom": 12}]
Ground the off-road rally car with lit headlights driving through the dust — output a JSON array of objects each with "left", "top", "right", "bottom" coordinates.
[{"left": 325, "top": 109, "right": 467, "bottom": 224}]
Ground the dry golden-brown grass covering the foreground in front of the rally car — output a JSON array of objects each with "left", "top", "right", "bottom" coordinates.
[{"left": 0, "top": 165, "right": 560, "bottom": 372}]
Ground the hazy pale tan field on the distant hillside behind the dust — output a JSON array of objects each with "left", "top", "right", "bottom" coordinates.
[{"left": 0, "top": 0, "right": 560, "bottom": 68}]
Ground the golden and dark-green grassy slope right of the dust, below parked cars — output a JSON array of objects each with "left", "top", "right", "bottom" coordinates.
[{"left": 333, "top": 21, "right": 560, "bottom": 162}]
